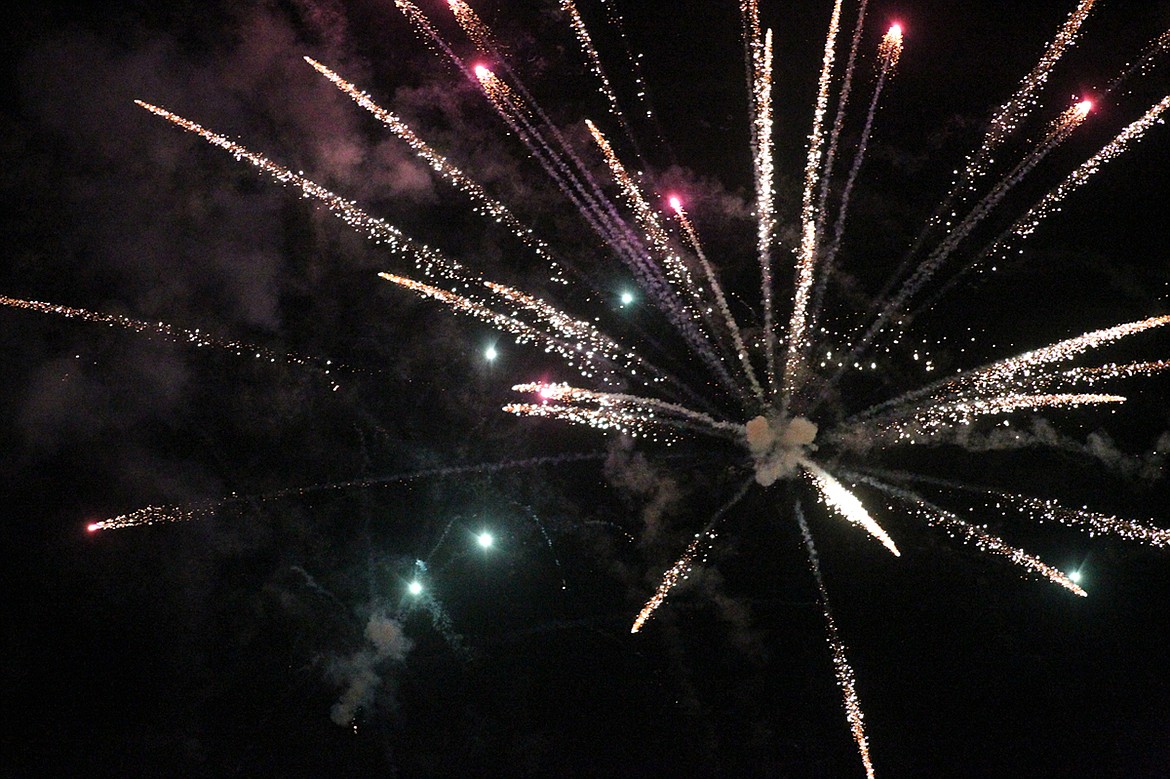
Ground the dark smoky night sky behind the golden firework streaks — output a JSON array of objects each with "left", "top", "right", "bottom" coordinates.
[{"left": 0, "top": 0, "right": 1170, "bottom": 777}]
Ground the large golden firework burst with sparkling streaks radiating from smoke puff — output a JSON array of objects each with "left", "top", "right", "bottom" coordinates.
[{"left": 11, "top": 0, "right": 1170, "bottom": 777}]
